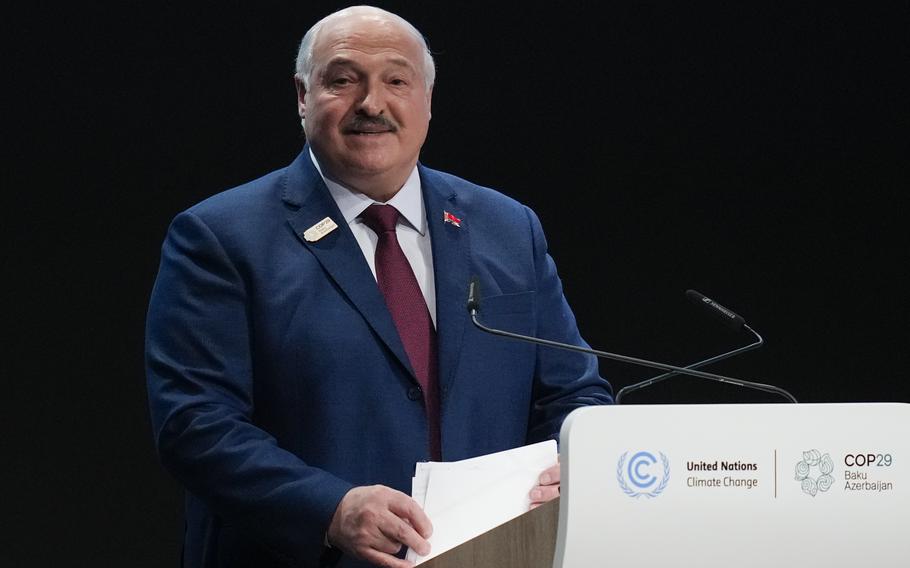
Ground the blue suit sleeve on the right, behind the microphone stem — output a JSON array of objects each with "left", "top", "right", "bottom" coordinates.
[{"left": 526, "top": 209, "right": 613, "bottom": 442}]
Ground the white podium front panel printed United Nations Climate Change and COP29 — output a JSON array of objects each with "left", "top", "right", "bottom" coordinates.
[{"left": 554, "top": 403, "right": 910, "bottom": 568}]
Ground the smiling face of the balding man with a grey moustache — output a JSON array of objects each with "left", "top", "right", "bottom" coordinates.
[{"left": 298, "top": 15, "right": 432, "bottom": 199}]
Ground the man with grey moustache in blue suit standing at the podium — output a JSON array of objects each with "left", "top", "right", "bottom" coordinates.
[{"left": 146, "top": 6, "right": 612, "bottom": 567}]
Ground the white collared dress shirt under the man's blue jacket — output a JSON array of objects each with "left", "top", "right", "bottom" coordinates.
[{"left": 310, "top": 150, "right": 436, "bottom": 326}]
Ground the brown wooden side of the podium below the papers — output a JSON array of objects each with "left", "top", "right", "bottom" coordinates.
[{"left": 420, "top": 498, "right": 559, "bottom": 568}]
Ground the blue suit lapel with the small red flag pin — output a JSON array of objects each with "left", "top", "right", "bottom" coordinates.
[{"left": 420, "top": 166, "right": 471, "bottom": 400}]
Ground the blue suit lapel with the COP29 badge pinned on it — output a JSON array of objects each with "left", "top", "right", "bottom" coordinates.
[{"left": 282, "top": 151, "right": 418, "bottom": 380}]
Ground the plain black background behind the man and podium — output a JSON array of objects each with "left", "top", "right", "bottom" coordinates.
[{"left": 0, "top": 1, "right": 910, "bottom": 566}]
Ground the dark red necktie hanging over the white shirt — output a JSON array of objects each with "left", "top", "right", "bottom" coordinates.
[{"left": 360, "top": 204, "right": 441, "bottom": 461}]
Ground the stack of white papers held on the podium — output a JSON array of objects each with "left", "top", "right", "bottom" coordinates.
[{"left": 407, "top": 440, "right": 557, "bottom": 564}]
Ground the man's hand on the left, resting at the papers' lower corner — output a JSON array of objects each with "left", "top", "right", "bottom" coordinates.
[{"left": 328, "top": 485, "right": 433, "bottom": 568}]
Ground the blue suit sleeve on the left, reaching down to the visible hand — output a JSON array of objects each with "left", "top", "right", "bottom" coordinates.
[{"left": 146, "top": 212, "right": 351, "bottom": 561}]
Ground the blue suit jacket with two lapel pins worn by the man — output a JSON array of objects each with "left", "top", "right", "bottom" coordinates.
[{"left": 146, "top": 148, "right": 612, "bottom": 567}]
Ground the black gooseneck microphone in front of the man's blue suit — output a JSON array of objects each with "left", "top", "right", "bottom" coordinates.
[{"left": 467, "top": 277, "right": 798, "bottom": 402}]
